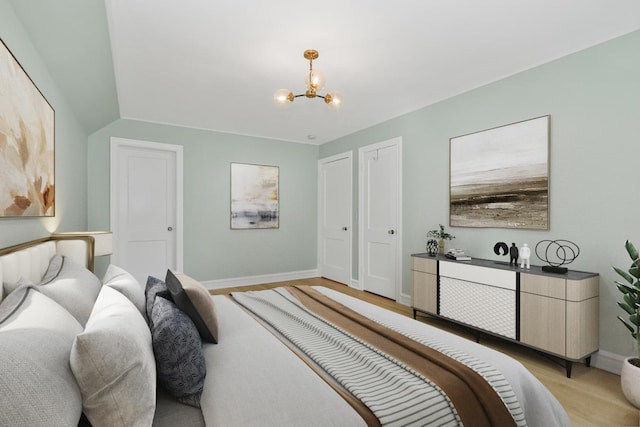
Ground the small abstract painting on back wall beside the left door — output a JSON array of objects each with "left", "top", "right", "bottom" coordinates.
[{"left": 230, "top": 163, "right": 280, "bottom": 230}]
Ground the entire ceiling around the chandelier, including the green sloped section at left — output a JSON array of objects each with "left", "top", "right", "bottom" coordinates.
[{"left": 11, "top": 0, "right": 640, "bottom": 144}]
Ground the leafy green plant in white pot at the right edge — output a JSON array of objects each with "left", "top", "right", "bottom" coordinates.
[{"left": 612, "top": 240, "right": 640, "bottom": 408}]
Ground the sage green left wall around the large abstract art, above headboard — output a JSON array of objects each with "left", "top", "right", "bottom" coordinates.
[{"left": 0, "top": 0, "right": 87, "bottom": 247}]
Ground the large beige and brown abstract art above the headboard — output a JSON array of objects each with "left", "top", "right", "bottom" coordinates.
[{"left": 0, "top": 40, "right": 55, "bottom": 217}]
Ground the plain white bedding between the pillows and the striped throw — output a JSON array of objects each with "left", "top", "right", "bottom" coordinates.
[{"left": 201, "top": 296, "right": 366, "bottom": 427}]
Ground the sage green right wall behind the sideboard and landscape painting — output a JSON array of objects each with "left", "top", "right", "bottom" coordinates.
[{"left": 320, "top": 32, "right": 640, "bottom": 354}]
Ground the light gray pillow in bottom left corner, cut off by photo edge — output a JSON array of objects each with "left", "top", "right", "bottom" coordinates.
[{"left": 0, "top": 286, "right": 82, "bottom": 427}]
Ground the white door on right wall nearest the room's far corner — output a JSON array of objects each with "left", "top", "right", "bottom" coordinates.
[{"left": 318, "top": 152, "right": 352, "bottom": 285}]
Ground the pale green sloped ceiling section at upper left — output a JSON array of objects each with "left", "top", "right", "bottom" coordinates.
[{"left": 10, "top": 0, "right": 120, "bottom": 133}]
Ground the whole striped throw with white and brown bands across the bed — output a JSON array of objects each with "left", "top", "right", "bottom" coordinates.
[{"left": 232, "top": 287, "right": 526, "bottom": 427}]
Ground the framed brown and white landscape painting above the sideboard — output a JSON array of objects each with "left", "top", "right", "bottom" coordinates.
[{"left": 449, "top": 115, "right": 551, "bottom": 230}]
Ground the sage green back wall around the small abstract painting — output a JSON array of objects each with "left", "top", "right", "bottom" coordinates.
[{"left": 88, "top": 120, "right": 318, "bottom": 281}]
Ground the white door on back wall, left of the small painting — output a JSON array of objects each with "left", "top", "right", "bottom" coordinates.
[{"left": 111, "top": 138, "right": 182, "bottom": 284}]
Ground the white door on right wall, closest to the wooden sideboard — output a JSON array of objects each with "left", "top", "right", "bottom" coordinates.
[{"left": 359, "top": 138, "right": 402, "bottom": 300}]
